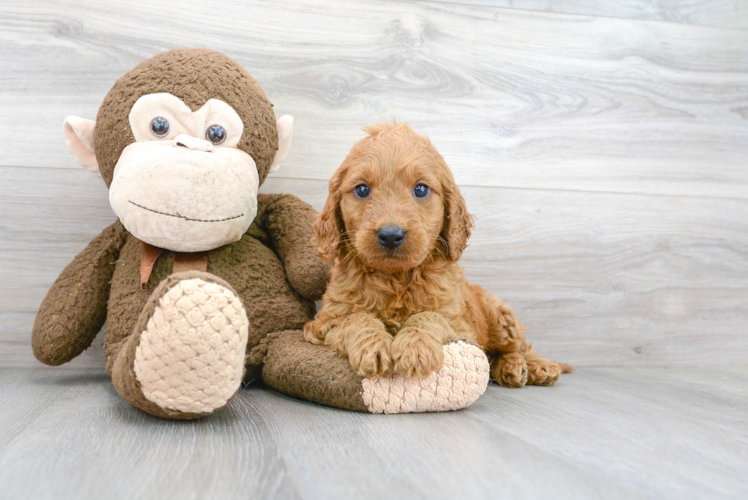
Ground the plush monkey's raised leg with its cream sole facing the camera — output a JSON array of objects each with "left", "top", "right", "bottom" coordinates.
[{"left": 112, "top": 271, "right": 249, "bottom": 419}]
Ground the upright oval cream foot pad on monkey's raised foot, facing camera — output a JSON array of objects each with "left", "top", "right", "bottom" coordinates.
[{"left": 134, "top": 278, "right": 249, "bottom": 413}]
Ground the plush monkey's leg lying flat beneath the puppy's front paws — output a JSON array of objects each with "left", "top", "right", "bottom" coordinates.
[{"left": 262, "top": 331, "right": 489, "bottom": 413}]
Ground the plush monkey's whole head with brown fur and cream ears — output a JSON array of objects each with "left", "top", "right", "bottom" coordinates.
[{"left": 63, "top": 49, "right": 293, "bottom": 252}]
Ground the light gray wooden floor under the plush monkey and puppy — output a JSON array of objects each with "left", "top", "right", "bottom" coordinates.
[{"left": 0, "top": 366, "right": 748, "bottom": 499}]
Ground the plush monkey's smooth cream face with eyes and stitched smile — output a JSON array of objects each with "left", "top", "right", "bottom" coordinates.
[{"left": 109, "top": 93, "right": 260, "bottom": 252}]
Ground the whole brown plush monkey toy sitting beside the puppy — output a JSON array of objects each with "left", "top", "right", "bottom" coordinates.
[{"left": 32, "top": 49, "right": 488, "bottom": 419}]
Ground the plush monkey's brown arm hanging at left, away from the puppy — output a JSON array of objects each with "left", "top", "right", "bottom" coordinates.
[{"left": 31, "top": 221, "right": 127, "bottom": 365}]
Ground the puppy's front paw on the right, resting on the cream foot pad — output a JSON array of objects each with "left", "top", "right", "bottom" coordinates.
[{"left": 390, "top": 328, "right": 444, "bottom": 378}]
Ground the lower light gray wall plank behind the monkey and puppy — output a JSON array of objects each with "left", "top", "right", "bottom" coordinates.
[{"left": 0, "top": 168, "right": 748, "bottom": 366}]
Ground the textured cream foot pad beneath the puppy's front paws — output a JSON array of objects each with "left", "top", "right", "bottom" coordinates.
[{"left": 362, "top": 341, "right": 489, "bottom": 413}]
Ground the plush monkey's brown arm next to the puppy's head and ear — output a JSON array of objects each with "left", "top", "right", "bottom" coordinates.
[{"left": 255, "top": 194, "right": 330, "bottom": 300}]
